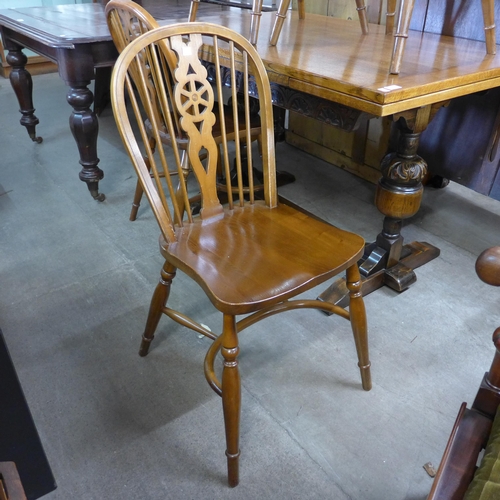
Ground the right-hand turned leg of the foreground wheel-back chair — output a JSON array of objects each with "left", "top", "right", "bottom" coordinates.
[{"left": 346, "top": 264, "right": 372, "bottom": 391}]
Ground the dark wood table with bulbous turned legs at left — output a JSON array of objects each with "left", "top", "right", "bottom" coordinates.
[{"left": 0, "top": 0, "right": 221, "bottom": 201}]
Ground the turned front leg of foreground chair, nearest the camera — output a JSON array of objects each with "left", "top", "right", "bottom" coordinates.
[{"left": 221, "top": 314, "right": 241, "bottom": 488}]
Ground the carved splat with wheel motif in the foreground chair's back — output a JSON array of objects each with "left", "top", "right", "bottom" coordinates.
[{"left": 170, "top": 34, "right": 223, "bottom": 219}]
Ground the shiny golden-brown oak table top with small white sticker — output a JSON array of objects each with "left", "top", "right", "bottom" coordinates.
[{"left": 221, "top": 12, "right": 500, "bottom": 116}]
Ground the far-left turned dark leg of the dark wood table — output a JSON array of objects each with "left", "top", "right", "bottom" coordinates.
[{"left": 6, "top": 47, "right": 43, "bottom": 143}]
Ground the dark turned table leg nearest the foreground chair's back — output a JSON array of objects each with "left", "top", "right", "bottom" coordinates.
[{"left": 66, "top": 82, "right": 106, "bottom": 201}]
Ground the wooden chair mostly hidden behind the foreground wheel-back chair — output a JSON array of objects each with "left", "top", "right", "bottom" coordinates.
[{"left": 105, "top": 0, "right": 261, "bottom": 221}]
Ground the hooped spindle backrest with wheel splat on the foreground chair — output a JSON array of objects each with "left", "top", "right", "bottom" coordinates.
[{"left": 111, "top": 23, "right": 277, "bottom": 242}]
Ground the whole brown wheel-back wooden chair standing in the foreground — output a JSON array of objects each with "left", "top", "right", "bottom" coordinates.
[{"left": 111, "top": 23, "right": 371, "bottom": 486}]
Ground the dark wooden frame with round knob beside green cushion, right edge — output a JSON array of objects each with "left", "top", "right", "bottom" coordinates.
[{"left": 427, "top": 247, "right": 500, "bottom": 500}]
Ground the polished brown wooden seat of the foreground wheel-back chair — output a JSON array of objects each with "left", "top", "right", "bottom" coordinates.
[{"left": 161, "top": 201, "right": 364, "bottom": 314}]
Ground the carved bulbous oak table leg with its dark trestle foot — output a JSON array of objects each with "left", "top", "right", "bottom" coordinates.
[{"left": 319, "top": 103, "right": 444, "bottom": 306}]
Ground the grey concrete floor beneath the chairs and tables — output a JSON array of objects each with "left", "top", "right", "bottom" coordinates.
[{"left": 0, "top": 74, "right": 500, "bottom": 500}]
